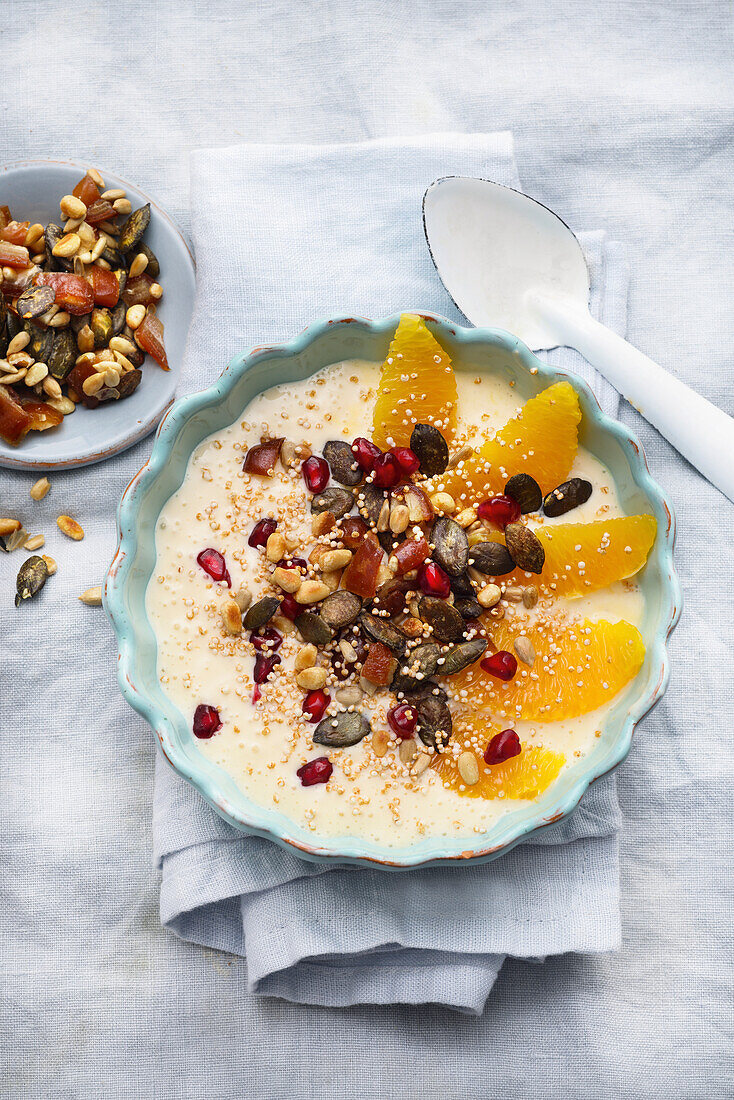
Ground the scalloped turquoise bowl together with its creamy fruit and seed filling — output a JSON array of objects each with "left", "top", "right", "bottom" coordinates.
[{"left": 105, "top": 315, "right": 679, "bottom": 869}]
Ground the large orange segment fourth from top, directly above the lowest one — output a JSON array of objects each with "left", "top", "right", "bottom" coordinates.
[{"left": 451, "top": 619, "right": 645, "bottom": 722}]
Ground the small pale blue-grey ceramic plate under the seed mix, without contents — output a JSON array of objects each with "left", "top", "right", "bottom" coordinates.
[{"left": 0, "top": 161, "right": 195, "bottom": 470}]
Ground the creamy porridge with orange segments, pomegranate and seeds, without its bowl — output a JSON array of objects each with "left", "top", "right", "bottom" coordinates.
[{"left": 147, "top": 315, "right": 655, "bottom": 845}]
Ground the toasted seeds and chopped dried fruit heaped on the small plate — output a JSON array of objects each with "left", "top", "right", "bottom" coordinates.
[{"left": 0, "top": 168, "right": 168, "bottom": 446}]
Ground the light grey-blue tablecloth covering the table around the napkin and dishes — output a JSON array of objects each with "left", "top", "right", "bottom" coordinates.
[{"left": 0, "top": 0, "right": 734, "bottom": 1100}]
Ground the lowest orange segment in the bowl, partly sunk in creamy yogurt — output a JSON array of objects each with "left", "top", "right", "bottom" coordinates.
[{"left": 431, "top": 734, "right": 566, "bottom": 799}]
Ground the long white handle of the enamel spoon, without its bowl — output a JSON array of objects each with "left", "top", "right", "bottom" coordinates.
[{"left": 534, "top": 296, "right": 734, "bottom": 501}]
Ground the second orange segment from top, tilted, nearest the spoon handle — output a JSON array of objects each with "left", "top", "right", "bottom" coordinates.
[{"left": 436, "top": 382, "right": 581, "bottom": 505}]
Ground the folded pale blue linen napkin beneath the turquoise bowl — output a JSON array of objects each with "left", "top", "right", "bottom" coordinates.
[{"left": 153, "top": 134, "right": 626, "bottom": 1013}]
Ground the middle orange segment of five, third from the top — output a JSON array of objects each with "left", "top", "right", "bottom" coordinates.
[{"left": 497, "top": 516, "right": 657, "bottom": 597}]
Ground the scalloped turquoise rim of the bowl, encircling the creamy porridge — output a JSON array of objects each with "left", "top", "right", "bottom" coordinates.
[{"left": 103, "top": 310, "right": 681, "bottom": 870}]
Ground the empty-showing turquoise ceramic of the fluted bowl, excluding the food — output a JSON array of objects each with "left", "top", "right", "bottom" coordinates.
[{"left": 105, "top": 315, "right": 680, "bottom": 869}]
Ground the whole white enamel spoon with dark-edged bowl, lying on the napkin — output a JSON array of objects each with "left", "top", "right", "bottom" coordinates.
[{"left": 423, "top": 176, "right": 734, "bottom": 501}]
